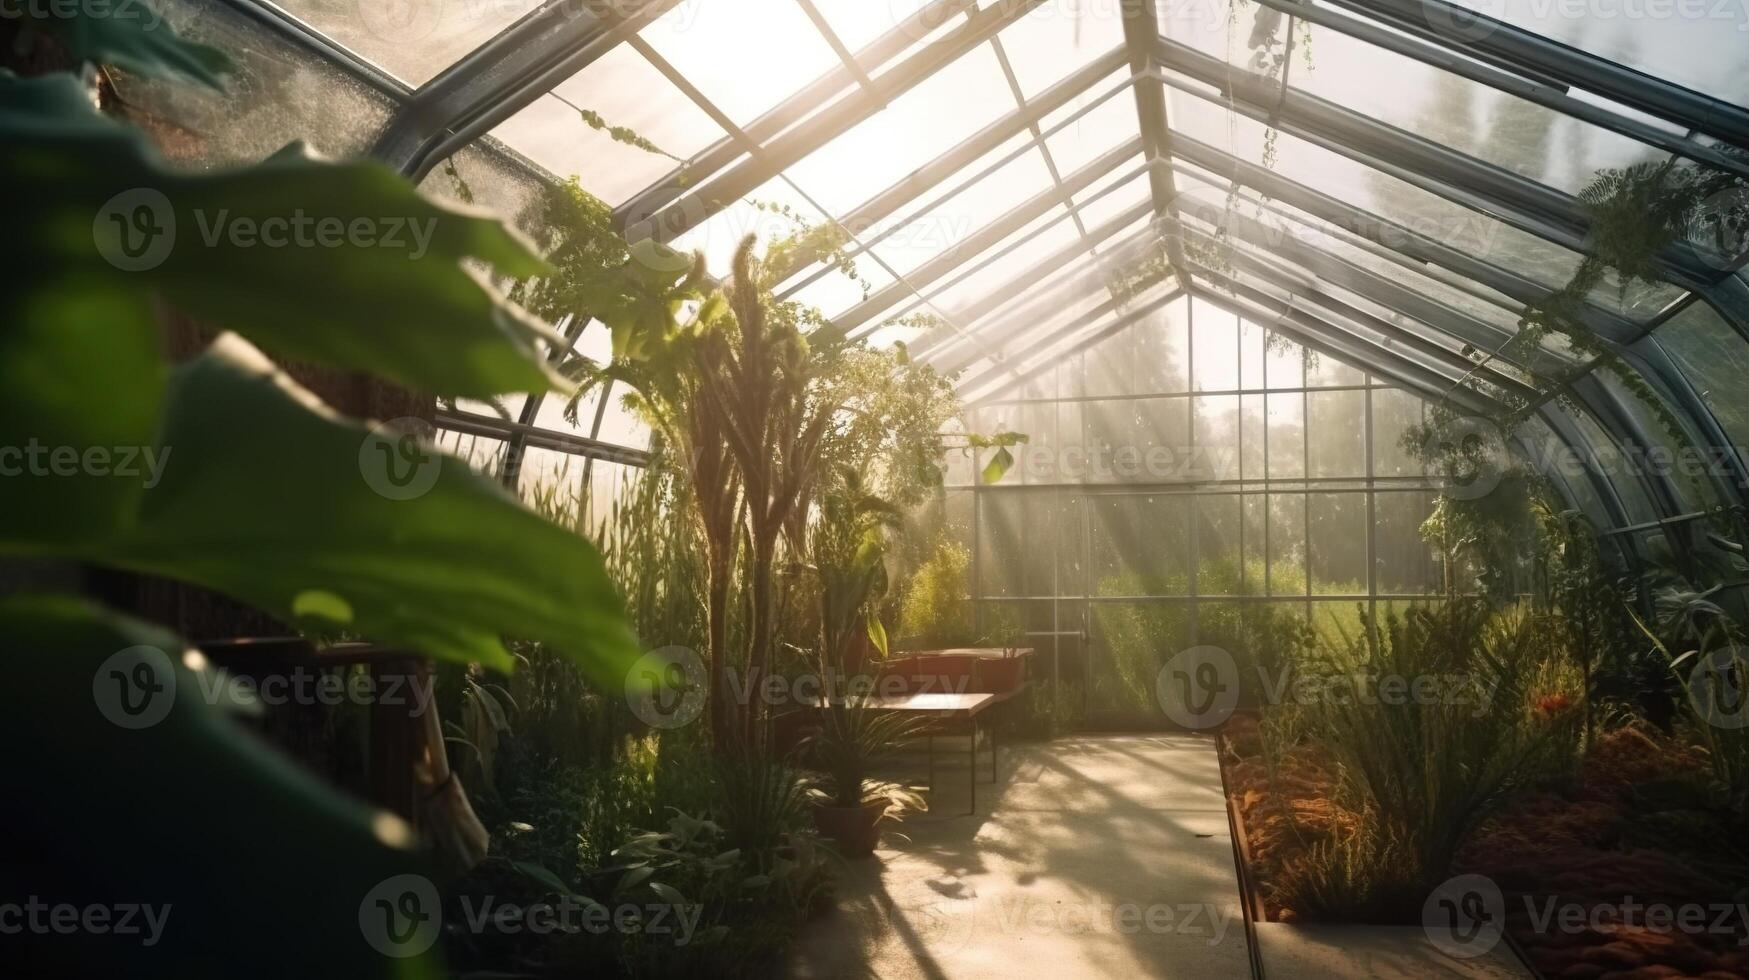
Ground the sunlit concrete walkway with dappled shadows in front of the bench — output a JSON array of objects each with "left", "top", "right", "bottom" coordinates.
[{"left": 784, "top": 735, "right": 1251, "bottom": 980}]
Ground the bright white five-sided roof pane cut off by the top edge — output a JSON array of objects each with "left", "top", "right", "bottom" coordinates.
[{"left": 633, "top": 0, "right": 840, "bottom": 126}]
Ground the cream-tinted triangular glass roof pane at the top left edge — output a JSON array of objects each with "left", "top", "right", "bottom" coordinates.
[{"left": 262, "top": 0, "right": 542, "bottom": 86}]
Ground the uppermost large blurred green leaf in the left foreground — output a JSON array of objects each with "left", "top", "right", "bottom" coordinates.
[{"left": 0, "top": 75, "right": 567, "bottom": 397}]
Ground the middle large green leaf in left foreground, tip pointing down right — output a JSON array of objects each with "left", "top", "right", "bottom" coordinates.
[{"left": 0, "top": 334, "right": 637, "bottom": 681}]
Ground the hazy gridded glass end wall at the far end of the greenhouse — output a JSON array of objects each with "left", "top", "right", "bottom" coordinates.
[{"left": 948, "top": 290, "right": 1441, "bottom": 725}]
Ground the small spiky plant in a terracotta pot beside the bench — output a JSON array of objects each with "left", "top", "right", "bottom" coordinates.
[{"left": 808, "top": 693, "right": 927, "bottom": 858}]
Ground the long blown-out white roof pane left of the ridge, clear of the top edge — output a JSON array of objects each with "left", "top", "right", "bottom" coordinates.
[{"left": 789, "top": 44, "right": 1014, "bottom": 214}]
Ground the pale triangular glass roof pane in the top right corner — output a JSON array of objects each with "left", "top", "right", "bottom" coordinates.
[{"left": 1453, "top": 0, "right": 1749, "bottom": 105}]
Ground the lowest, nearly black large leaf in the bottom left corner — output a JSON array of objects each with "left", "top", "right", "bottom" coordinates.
[{"left": 0, "top": 595, "right": 437, "bottom": 980}]
